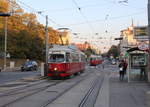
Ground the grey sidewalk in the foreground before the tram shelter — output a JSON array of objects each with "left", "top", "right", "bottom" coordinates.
[{"left": 109, "top": 73, "right": 150, "bottom": 107}]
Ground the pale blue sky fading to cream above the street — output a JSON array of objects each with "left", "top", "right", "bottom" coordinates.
[{"left": 16, "top": 0, "right": 148, "bottom": 51}]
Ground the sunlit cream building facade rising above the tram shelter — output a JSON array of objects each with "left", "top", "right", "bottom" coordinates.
[{"left": 120, "top": 25, "right": 148, "bottom": 56}]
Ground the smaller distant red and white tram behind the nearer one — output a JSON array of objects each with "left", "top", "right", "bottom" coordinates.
[{"left": 90, "top": 55, "right": 103, "bottom": 66}]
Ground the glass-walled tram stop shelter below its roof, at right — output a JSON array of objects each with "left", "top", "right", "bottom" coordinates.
[{"left": 128, "top": 53, "right": 148, "bottom": 81}]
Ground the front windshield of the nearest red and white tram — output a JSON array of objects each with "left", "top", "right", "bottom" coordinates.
[{"left": 49, "top": 54, "right": 65, "bottom": 62}]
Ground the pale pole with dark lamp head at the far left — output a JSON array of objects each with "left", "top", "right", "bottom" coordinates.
[{"left": 0, "top": 13, "right": 10, "bottom": 70}]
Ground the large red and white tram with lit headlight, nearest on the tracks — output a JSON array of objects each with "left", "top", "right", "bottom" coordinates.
[{"left": 47, "top": 46, "right": 85, "bottom": 77}]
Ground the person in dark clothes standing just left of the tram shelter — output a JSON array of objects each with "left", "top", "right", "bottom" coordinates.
[{"left": 119, "top": 60, "right": 127, "bottom": 81}]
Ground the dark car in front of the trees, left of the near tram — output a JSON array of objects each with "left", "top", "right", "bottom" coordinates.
[{"left": 21, "top": 61, "right": 38, "bottom": 71}]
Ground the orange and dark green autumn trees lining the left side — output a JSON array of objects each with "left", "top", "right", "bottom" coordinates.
[{"left": 0, "top": 0, "right": 59, "bottom": 60}]
